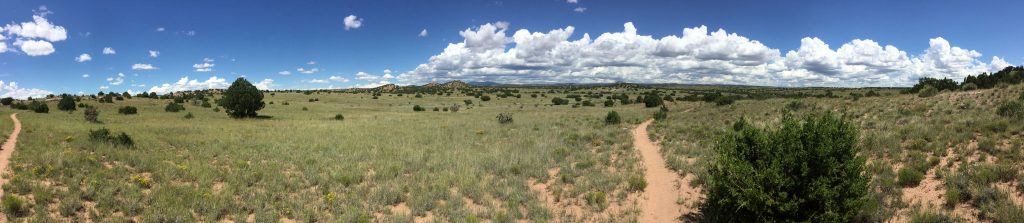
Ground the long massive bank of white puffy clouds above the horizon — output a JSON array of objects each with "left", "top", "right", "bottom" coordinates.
[{"left": 397, "top": 23, "right": 1007, "bottom": 86}]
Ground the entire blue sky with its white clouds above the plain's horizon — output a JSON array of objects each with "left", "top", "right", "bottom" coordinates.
[{"left": 0, "top": 0, "right": 1024, "bottom": 97}]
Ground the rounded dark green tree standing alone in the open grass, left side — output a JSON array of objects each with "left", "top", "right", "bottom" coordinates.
[{"left": 218, "top": 78, "right": 265, "bottom": 119}]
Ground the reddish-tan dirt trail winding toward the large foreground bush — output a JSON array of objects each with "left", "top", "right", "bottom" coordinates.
[{"left": 633, "top": 120, "right": 694, "bottom": 222}]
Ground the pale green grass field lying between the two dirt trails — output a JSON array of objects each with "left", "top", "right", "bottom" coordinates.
[{"left": 0, "top": 89, "right": 647, "bottom": 222}]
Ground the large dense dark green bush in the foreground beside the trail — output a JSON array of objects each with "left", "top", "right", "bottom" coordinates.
[{"left": 701, "top": 113, "right": 867, "bottom": 222}]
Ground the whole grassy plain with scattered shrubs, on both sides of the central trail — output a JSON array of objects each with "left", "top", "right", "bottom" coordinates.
[{"left": 0, "top": 82, "right": 1024, "bottom": 222}]
